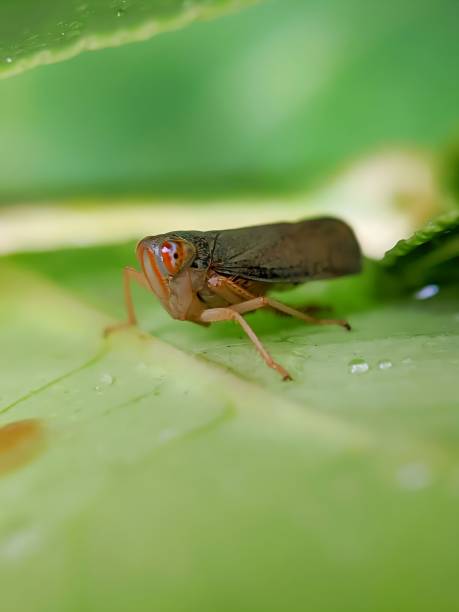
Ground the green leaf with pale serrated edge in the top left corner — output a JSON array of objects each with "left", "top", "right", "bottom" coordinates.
[{"left": 0, "top": 0, "right": 253, "bottom": 78}]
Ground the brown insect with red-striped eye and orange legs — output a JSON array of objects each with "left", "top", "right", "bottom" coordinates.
[{"left": 106, "top": 218, "right": 361, "bottom": 380}]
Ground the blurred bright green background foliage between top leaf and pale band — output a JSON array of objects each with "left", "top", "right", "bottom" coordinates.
[{"left": 0, "top": 0, "right": 459, "bottom": 200}]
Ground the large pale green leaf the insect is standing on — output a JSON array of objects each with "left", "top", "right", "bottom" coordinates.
[{"left": 0, "top": 240, "right": 459, "bottom": 612}]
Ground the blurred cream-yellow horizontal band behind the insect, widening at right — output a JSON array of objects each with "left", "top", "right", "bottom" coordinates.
[{"left": 0, "top": 151, "right": 445, "bottom": 259}]
